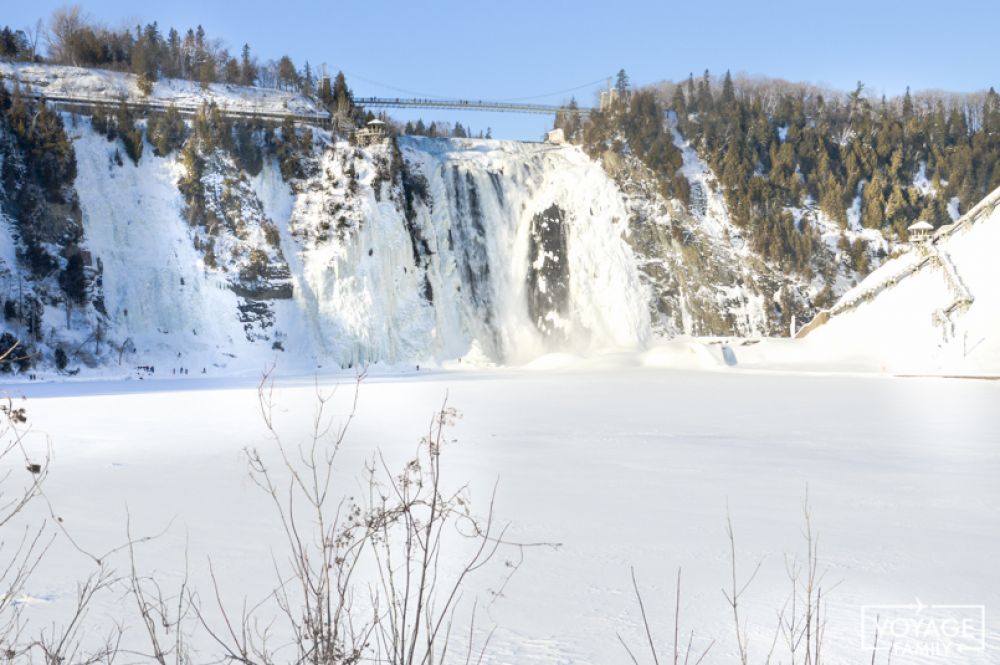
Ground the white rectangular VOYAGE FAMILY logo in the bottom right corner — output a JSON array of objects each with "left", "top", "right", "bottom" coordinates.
[{"left": 861, "top": 598, "right": 986, "bottom": 659}]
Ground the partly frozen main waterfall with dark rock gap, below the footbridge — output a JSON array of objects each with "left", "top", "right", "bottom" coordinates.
[{"left": 401, "top": 139, "right": 650, "bottom": 362}]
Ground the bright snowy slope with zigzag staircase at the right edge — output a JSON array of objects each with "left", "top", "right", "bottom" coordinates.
[{"left": 802, "top": 190, "right": 1000, "bottom": 374}]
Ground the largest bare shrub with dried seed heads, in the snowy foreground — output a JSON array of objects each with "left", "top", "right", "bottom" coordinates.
[{"left": 189, "top": 375, "right": 528, "bottom": 665}]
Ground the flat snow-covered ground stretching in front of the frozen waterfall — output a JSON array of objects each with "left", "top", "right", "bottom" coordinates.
[{"left": 7, "top": 368, "right": 1000, "bottom": 665}]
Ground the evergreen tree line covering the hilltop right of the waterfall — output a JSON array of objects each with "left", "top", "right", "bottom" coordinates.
[{"left": 557, "top": 71, "right": 1000, "bottom": 272}]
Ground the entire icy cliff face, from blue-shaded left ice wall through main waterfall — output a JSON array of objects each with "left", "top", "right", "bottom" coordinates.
[{"left": 2, "top": 121, "right": 650, "bottom": 372}]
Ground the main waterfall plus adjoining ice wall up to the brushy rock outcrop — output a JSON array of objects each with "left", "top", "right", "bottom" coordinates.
[{"left": 257, "top": 138, "right": 649, "bottom": 366}]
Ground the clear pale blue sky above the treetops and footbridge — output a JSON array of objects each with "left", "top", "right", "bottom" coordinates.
[{"left": 0, "top": 0, "right": 1000, "bottom": 138}]
